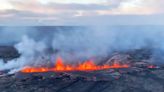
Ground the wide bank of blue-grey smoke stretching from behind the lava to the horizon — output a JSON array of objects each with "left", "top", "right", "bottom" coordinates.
[{"left": 0, "top": 26, "right": 164, "bottom": 73}]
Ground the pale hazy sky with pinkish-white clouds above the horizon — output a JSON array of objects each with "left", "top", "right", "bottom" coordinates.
[{"left": 0, "top": 0, "right": 164, "bottom": 25}]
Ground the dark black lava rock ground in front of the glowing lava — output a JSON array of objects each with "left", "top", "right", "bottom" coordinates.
[{"left": 0, "top": 69, "right": 164, "bottom": 92}]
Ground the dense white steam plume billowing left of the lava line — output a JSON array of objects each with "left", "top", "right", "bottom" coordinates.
[{"left": 0, "top": 36, "right": 46, "bottom": 73}]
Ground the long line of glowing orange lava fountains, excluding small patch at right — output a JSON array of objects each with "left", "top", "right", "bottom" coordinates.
[{"left": 21, "top": 57, "right": 129, "bottom": 73}]
